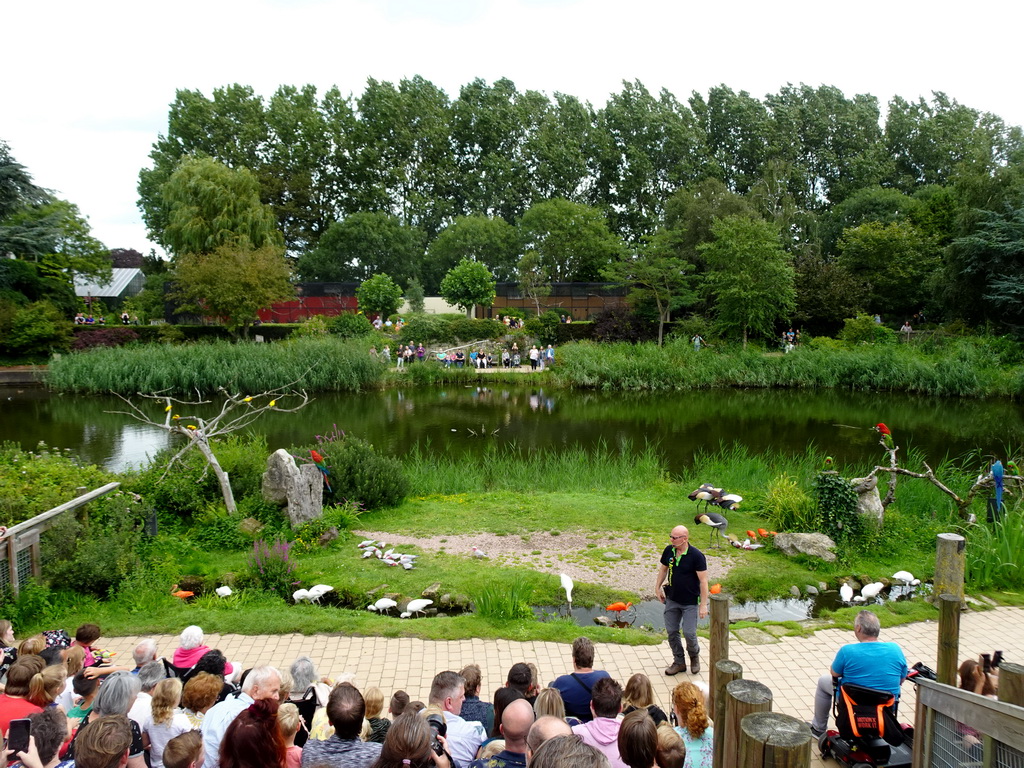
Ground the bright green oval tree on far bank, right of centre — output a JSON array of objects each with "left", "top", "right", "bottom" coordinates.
[{"left": 698, "top": 216, "right": 796, "bottom": 348}]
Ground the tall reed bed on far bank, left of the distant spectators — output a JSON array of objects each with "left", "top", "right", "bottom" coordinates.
[{"left": 46, "top": 338, "right": 385, "bottom": 394}]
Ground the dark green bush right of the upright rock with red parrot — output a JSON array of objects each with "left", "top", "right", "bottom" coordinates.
[{"left": 292, "top": 430, "right": 407, "bottom": 510}]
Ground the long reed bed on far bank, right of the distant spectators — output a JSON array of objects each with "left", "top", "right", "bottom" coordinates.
[{"left": 554, "top": 340, "right": 1024, "bottom": 397}]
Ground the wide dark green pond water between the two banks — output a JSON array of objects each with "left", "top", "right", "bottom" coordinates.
[{"left": 0, "top": 385, "right": 1024, "bottom": 472}]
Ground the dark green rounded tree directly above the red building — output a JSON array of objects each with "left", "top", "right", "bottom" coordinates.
[{"left": 296, "top": 211, "right": 423, "bottom": 285}]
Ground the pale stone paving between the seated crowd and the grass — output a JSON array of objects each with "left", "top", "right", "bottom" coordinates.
[{"left": 99, "top": 607, "right": 1024, "bottom": 763}]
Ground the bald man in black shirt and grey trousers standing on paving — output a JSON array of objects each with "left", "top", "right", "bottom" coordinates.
[{"left": 654, "top": 525, "right": 710, "bottom": 675}]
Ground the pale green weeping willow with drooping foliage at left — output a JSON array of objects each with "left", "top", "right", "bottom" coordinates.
[{"left": 162, "top": 157, "right": 283, "bottom": 256}]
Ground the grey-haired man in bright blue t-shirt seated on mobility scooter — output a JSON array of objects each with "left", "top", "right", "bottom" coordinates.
[{"left": 810, "top": 610, "right": 909, "bottom": 738}]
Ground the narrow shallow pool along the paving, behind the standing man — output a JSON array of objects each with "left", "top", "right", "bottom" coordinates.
[{"left": 534, "top": 586, "right": 925, "bottom": 630}]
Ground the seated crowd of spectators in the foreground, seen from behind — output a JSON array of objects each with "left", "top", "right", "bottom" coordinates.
[{"left": 0, "top": 622, "right": 713, "bottom": 768}]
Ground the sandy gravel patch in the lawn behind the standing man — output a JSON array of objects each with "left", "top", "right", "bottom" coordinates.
[{"left": 353, "top": 530, "right": 731, "bottom": 599}]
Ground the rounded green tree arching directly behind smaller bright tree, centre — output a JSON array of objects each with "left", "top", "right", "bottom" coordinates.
[{"left": 423, "top": 215, "right": 519, "bottom": 292}]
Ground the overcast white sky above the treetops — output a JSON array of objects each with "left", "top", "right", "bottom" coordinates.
[{"left": 0, "top": 0, "right": 1024, "bottom": 259}]
